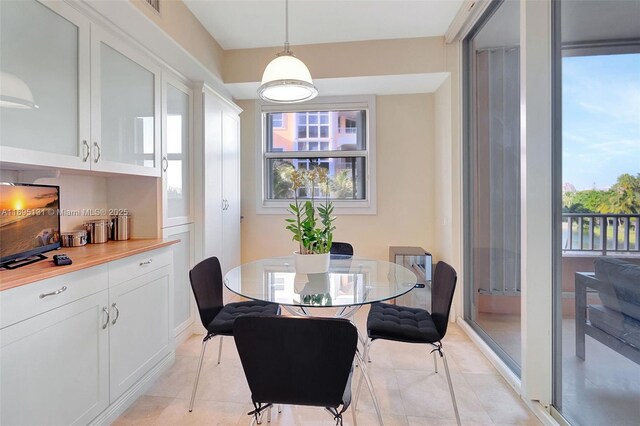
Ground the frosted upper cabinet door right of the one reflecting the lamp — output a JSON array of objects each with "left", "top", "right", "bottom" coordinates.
[{"left": 91, "top": 25, "right": 160, "bottom": 177}]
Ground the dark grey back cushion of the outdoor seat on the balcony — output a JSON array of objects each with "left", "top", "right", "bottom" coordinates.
[{"left": 594, "top": 257, "right": 640, "bottom": 321}]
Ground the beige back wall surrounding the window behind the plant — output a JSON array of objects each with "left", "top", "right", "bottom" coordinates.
[{"left": 238, "top": 94, "right": 436, "bottom": 262}]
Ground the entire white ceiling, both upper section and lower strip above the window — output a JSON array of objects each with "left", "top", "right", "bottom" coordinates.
[{"left": 184, "top": 0, "right": 464, "bottom": 99}]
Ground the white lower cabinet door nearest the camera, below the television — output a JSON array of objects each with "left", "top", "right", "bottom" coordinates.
[{"left": 0, "top": 290, "right": 109, "bottom": 425}]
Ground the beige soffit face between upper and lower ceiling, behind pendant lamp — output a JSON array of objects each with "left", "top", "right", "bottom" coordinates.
[{"left": 223, "top": 37, "right": 446, "bottom": 83}]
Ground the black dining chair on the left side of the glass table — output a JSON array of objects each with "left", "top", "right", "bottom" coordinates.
[{"left": 189, "top": 257, "right": 280, "bottom": 411}]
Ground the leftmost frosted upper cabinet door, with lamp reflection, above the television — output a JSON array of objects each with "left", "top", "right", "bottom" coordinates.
[{"left": 0, "top": 0, "right": 90, "bottom": 169}]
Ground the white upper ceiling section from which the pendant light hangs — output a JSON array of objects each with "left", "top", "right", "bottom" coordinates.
[{"left": 184, "top": 0, "right": 463, "bottom": 50}]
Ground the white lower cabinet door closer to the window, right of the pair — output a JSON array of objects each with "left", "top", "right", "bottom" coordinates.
[{"left": 109, "top": 266, "right": 173, "bottom": 402}]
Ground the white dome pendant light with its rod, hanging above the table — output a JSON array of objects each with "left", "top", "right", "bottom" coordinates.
[{"left": 258, "top": 0, "right": 318, "bottom": 104}]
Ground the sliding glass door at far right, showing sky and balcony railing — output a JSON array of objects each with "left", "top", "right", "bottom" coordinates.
[{"left": 553, "top": 0, "right": 640, "bottom": 425}]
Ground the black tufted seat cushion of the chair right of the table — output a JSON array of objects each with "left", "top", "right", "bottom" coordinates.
[{"left": 367, "top": 303, "right": 440, "bottom": 343}]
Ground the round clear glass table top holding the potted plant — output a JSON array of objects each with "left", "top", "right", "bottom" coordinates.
[{"left": 224, "top": 256, "right": 416, "bottom": 307}]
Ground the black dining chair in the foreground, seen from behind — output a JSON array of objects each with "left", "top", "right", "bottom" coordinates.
[{"left": 233, "top": 315, "right": 358, "bottom": 425}]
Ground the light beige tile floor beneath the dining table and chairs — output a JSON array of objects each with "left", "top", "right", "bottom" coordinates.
[{"left": 114, "top": 308, "right": 540, "bottom": 426}]
